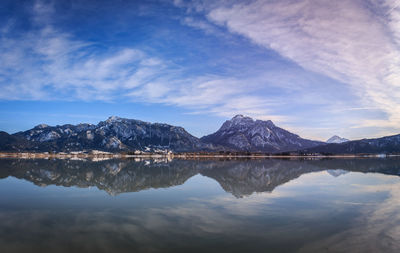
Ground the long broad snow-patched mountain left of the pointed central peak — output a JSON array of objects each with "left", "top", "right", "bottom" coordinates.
[{"left": 12, "top": 116, "right": 214, "bottom": 151}]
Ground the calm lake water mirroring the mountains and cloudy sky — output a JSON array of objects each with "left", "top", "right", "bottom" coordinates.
[{"left": 0, "top": 159, "right": 400, "bottom": 253}]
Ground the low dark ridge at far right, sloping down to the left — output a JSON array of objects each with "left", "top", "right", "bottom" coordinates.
[{"left": 302, "top": 134, "right": 400, "bottom": 154}]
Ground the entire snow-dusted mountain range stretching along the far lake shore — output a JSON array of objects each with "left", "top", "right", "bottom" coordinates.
[{"left": 0, "top": 115, "right": 400, "bottom": 154}]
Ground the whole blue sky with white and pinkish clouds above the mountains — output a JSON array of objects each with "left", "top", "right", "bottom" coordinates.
[{"left": 0, "top": 0, "right": 400, "bottom": 140}]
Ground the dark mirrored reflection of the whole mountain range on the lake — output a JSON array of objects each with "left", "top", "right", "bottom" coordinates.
[{"left": 0, "top": 159, "right": 400, "bottom": 198}]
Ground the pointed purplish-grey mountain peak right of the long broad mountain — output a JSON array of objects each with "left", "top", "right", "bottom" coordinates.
[{"left": 201, "top": 115, "right": 324, "bottom": 152}]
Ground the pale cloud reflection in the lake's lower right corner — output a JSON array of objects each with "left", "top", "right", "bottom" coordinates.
[{"left": 299, "top": 179, "right": 400, "bottom": 252}]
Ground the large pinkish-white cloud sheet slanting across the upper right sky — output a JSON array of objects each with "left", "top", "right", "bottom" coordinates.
[{"left": 180, "top": 0, "right": 400, "bottom": 132}]
